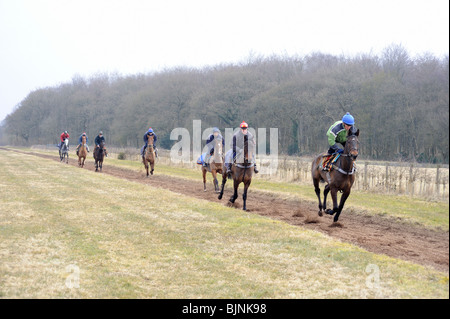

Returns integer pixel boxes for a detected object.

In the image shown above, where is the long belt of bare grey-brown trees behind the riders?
[4,45,449,163]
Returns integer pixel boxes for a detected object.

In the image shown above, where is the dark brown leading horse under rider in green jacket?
[311,130,359,222]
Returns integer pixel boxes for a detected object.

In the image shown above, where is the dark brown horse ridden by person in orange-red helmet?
[218,140,255,210]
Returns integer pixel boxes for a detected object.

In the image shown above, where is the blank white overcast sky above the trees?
[0,0,449,121]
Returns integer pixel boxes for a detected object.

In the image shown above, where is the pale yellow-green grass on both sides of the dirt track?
[0,150,449,298]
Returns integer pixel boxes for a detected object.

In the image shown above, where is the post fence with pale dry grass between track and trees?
[34,145,449,200]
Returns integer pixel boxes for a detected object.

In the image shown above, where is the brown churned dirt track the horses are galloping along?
[7,152,449,272]
